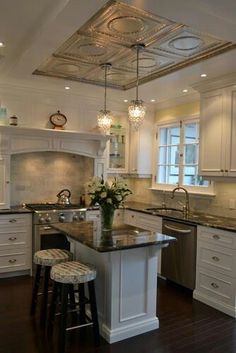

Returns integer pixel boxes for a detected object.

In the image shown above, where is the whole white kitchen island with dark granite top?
[53,221,175,343]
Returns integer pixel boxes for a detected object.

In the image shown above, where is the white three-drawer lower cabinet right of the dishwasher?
[193,226,236,317]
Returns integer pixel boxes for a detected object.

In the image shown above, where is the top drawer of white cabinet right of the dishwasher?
[198,226,236,249]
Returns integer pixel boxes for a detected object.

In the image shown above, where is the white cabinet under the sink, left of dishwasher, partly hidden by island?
[124,210,162,274]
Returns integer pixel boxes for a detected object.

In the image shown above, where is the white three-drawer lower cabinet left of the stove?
[0,214,32,276]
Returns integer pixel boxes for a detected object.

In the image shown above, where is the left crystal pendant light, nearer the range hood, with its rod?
[97,63,112,134]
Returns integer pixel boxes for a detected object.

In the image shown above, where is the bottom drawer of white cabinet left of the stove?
[0,250,31,273]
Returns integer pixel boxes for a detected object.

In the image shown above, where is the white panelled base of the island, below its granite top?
[70,239,167,343]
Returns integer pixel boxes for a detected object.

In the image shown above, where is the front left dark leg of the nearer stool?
[58,284,68,353]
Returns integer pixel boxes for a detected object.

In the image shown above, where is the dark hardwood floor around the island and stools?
[0,277,236,353]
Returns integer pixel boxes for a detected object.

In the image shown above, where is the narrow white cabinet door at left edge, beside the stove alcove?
[0,156,10,209]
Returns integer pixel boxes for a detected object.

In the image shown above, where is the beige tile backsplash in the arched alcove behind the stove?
[11,152,94,205]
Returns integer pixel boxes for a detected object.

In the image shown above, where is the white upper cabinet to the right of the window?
[195,76,236,177]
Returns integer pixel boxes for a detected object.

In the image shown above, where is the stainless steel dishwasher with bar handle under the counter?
[161,218,197,289]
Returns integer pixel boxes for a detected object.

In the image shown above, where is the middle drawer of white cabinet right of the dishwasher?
[197,242,236,277]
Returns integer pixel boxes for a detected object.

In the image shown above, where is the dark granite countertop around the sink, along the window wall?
[124,202,236,232]
